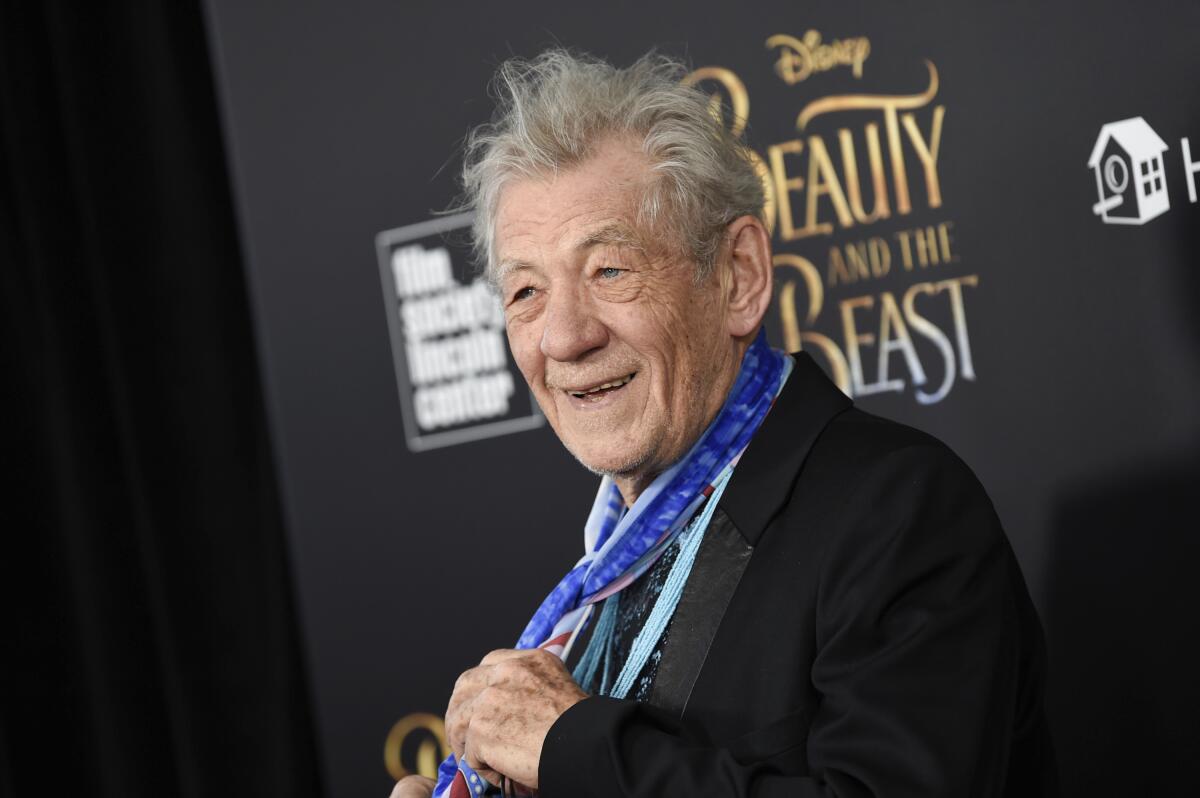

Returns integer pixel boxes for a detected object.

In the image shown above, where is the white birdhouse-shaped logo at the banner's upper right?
[1087,116,1171,224]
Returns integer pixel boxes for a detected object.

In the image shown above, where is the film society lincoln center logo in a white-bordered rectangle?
[376,214,545,451]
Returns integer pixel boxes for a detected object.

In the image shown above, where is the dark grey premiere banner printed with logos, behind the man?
[209,0,1200,798]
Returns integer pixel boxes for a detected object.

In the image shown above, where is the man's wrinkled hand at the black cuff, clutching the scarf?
[446,648,588,790]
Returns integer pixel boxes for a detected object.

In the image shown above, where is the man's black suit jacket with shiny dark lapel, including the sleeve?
[539,354,1057,798]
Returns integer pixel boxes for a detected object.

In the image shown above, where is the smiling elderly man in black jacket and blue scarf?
[392,50,1055,798]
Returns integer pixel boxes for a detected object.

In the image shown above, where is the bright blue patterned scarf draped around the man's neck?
[433,331,792,798]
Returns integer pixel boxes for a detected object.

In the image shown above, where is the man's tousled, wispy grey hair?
[462,48,764,283]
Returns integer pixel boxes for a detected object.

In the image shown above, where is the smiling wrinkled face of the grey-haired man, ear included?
[494,139,739,489]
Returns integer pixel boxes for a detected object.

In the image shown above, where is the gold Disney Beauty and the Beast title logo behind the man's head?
[686,30,979,404]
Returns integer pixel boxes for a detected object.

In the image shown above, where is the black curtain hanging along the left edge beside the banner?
[0,0,320,798]
